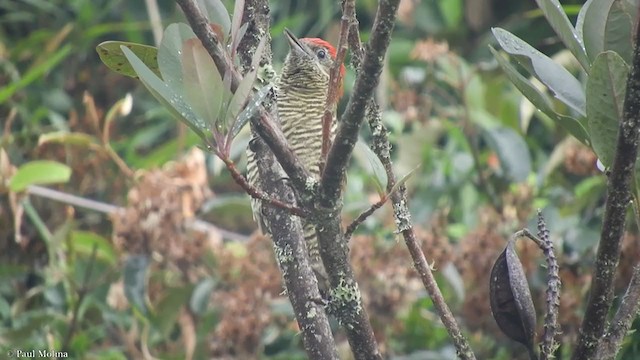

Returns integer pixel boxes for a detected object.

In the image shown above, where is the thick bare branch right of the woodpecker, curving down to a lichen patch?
[308,0,399,360]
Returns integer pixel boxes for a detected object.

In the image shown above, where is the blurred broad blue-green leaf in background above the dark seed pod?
[483,127,531,182]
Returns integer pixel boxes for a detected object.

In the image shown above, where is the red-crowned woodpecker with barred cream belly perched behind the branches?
[247,29,345,293]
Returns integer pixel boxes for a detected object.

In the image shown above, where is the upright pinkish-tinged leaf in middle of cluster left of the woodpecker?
[181,39,223,124]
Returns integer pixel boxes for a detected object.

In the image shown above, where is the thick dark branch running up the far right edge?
[572,21,640,360]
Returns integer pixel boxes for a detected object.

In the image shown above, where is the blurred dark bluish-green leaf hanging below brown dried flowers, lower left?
[122,255,150,314]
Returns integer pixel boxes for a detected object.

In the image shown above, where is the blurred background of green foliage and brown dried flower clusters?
[0,0,640,360]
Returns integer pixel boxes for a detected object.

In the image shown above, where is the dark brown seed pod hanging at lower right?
[489,237,537,359]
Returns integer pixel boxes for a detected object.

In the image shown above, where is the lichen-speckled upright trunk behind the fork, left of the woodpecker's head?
[238,0,338,360]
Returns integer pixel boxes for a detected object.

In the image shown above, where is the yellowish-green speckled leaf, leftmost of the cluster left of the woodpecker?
[96,41,160,77]
